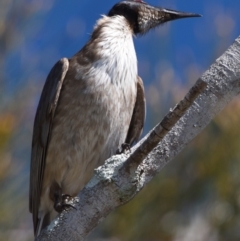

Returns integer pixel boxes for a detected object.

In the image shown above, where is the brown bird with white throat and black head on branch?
[29,0,200,237]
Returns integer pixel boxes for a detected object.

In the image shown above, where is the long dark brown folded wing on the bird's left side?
[29,58,69,232]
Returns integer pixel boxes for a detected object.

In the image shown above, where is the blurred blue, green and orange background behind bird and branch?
[0,0,240,241]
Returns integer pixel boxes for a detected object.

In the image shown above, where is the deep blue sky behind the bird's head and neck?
[6,0,240,94]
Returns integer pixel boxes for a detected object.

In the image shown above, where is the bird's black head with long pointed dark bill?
[108,0,201,34]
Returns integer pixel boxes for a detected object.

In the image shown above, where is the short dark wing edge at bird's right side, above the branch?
[125,76,146,145]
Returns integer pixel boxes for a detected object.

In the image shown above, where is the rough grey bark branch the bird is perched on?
[36,37,240,241]
